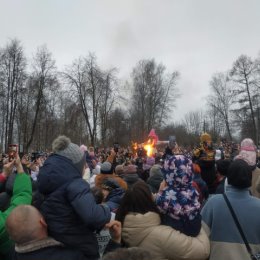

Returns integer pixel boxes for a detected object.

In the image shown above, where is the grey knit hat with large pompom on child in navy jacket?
[52,135,86,174]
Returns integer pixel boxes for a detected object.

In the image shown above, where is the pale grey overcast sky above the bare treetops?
[0,0,260,120]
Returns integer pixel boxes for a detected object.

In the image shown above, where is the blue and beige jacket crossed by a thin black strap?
[201,185,260,260]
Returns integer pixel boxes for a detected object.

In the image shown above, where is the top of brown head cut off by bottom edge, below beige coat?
[102,247,150,260]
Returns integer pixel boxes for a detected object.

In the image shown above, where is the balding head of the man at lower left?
[6,205,48,245]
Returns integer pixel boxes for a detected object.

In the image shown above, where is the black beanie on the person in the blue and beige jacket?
[227,159,252,189]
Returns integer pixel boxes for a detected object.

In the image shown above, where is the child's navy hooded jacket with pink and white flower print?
[156,155,200,220]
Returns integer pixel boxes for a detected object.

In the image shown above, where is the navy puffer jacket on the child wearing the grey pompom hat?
[38,154,111,259]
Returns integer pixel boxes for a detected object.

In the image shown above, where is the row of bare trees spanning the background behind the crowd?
[0,39,260,151]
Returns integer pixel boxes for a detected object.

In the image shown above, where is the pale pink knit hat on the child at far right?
[235,138,256,166]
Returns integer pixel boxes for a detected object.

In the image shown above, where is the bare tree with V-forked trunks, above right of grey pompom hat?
[63,54,112,146]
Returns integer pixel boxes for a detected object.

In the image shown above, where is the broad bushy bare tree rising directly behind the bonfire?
[131,60,178,141]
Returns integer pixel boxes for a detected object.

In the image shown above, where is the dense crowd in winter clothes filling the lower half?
[0,133,260,260]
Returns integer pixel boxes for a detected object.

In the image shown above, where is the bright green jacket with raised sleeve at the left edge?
[0,173,32,255]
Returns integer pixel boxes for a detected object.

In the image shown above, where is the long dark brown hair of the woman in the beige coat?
[116,181,159,223]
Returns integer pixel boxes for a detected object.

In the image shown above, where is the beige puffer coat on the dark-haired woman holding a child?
[122,212,210,260]
